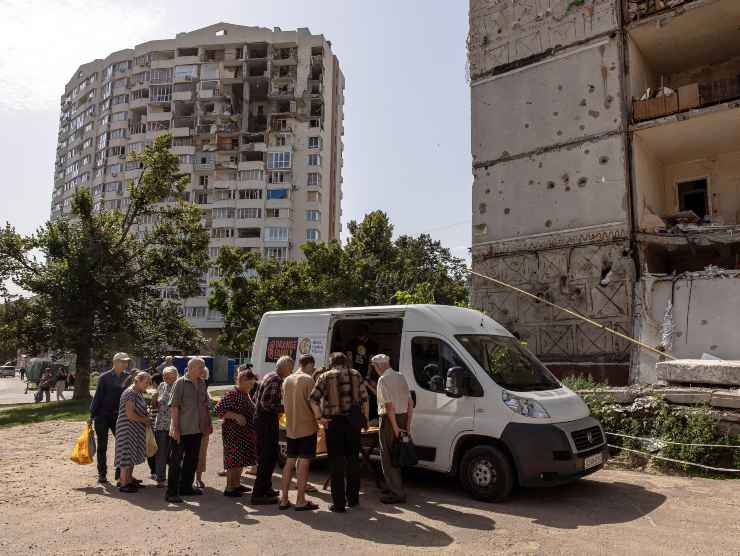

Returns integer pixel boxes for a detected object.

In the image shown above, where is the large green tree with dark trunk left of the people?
[0,135,208,399]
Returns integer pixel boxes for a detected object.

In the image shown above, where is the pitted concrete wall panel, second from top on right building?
[471,38,622,165]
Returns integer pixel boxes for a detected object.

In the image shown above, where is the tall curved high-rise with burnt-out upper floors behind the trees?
[51,23,344,336]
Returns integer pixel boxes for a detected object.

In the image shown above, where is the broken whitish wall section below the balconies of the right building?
[634,271,740,382]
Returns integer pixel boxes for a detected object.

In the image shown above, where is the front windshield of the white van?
[455,334,561,392]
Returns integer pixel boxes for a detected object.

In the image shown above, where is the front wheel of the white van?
[460,446,514,502]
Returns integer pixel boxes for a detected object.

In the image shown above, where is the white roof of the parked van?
[264,304,511,336]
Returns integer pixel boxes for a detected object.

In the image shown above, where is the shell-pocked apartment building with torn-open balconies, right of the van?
[469,0,740,384]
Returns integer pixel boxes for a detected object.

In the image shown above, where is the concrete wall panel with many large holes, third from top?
[473,135,628,244]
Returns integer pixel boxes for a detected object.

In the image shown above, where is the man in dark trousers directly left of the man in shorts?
[252,355,293,505]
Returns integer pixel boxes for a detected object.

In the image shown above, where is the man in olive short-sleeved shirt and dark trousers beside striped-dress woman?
[165,357,210,504]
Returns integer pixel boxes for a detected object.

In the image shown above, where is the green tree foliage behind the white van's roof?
[209,211,467,354]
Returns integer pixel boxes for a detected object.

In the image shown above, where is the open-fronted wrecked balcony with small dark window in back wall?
[632,109,740,273]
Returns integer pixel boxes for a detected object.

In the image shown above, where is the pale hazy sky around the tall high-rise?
[0,0,472,256]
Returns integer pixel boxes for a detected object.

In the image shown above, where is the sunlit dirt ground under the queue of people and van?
[0,422,740,556]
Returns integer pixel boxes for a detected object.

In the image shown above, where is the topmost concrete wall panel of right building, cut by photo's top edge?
[468,0,619,80]
